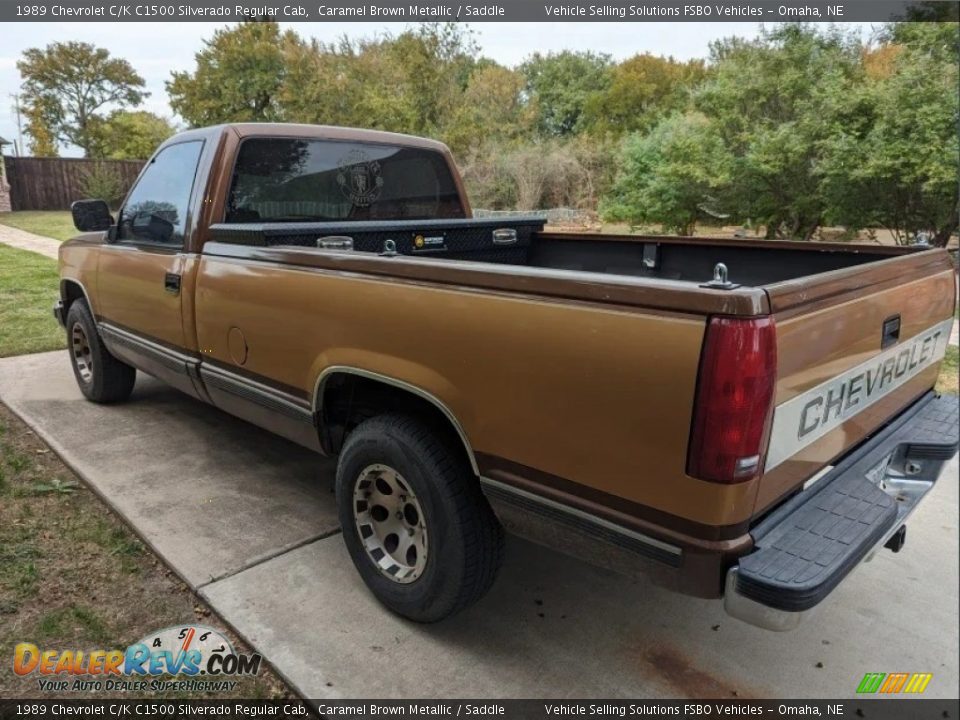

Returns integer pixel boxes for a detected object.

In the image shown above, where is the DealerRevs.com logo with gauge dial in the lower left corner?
[13,625,261,692]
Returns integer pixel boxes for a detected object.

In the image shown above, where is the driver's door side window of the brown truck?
[117,140,203,247]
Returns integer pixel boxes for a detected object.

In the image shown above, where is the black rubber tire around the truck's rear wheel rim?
[337,414,503,623]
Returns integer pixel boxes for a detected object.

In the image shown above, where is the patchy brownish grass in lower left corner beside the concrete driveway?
[0,404,294,704]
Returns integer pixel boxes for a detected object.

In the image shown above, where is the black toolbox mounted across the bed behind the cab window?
[210,216,546,264]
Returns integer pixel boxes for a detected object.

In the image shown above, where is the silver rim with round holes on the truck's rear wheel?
[353,465,428,584]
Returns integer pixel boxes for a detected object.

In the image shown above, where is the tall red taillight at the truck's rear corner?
[687,317,777,483]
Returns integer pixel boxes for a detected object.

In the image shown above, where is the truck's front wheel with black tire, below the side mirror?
[66,300,137,403]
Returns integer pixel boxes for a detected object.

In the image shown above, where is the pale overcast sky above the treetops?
[0,22,869,155]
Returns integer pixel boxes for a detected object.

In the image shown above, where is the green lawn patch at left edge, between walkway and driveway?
[0,244,66,357]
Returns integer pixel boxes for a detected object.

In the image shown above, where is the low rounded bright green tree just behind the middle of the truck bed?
[600,113,733,235]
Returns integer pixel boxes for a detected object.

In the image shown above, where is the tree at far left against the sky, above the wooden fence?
[17,42,149,155]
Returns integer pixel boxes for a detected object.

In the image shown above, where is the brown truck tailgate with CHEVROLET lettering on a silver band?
[755,250,956,514]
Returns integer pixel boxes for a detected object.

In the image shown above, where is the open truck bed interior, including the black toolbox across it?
[210,217,915,287]
